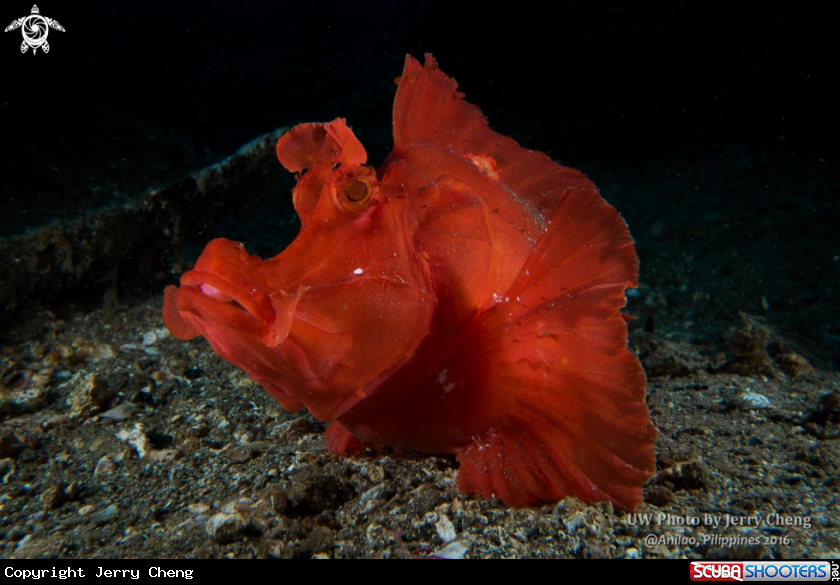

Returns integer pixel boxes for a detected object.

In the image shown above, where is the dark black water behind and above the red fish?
[0,0,840,369]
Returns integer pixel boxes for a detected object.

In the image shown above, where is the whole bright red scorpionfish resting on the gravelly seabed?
[163,55,656,509]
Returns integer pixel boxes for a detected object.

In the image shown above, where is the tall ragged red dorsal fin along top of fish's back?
[394,54,594,223]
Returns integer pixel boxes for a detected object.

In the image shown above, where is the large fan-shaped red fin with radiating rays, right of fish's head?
[450,188,656,509]
